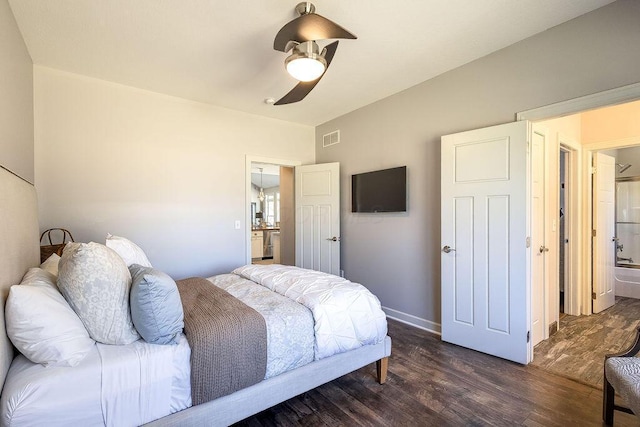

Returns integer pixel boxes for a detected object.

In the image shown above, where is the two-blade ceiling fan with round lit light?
[273,2,357,105]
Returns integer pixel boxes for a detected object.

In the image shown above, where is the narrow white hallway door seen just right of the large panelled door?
[531,124,549,346]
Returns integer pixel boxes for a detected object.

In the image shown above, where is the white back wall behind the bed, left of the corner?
[34,66,315,278]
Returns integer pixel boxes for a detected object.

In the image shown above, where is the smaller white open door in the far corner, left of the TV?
[295,163,340,276]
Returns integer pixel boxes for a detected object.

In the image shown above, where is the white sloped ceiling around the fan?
[9,0,613,125]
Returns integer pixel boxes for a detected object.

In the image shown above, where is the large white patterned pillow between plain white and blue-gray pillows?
[58,242,140,344]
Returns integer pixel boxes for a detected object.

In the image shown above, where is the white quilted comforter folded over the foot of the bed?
[233,264,387,360]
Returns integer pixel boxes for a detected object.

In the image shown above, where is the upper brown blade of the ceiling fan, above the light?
[273,13,357,52]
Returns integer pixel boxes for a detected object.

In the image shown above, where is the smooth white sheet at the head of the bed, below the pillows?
[0,336,191,427]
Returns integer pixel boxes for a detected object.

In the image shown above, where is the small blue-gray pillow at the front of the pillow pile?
[129,264,184,344]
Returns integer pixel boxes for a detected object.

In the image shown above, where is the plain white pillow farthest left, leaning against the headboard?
[5,268,95,366]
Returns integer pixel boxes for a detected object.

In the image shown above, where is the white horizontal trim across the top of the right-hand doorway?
[516,83,640,121]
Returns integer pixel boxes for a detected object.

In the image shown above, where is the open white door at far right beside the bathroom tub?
[593,153,616,313]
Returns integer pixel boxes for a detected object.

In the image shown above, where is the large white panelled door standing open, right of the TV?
[441,121,532,364]
